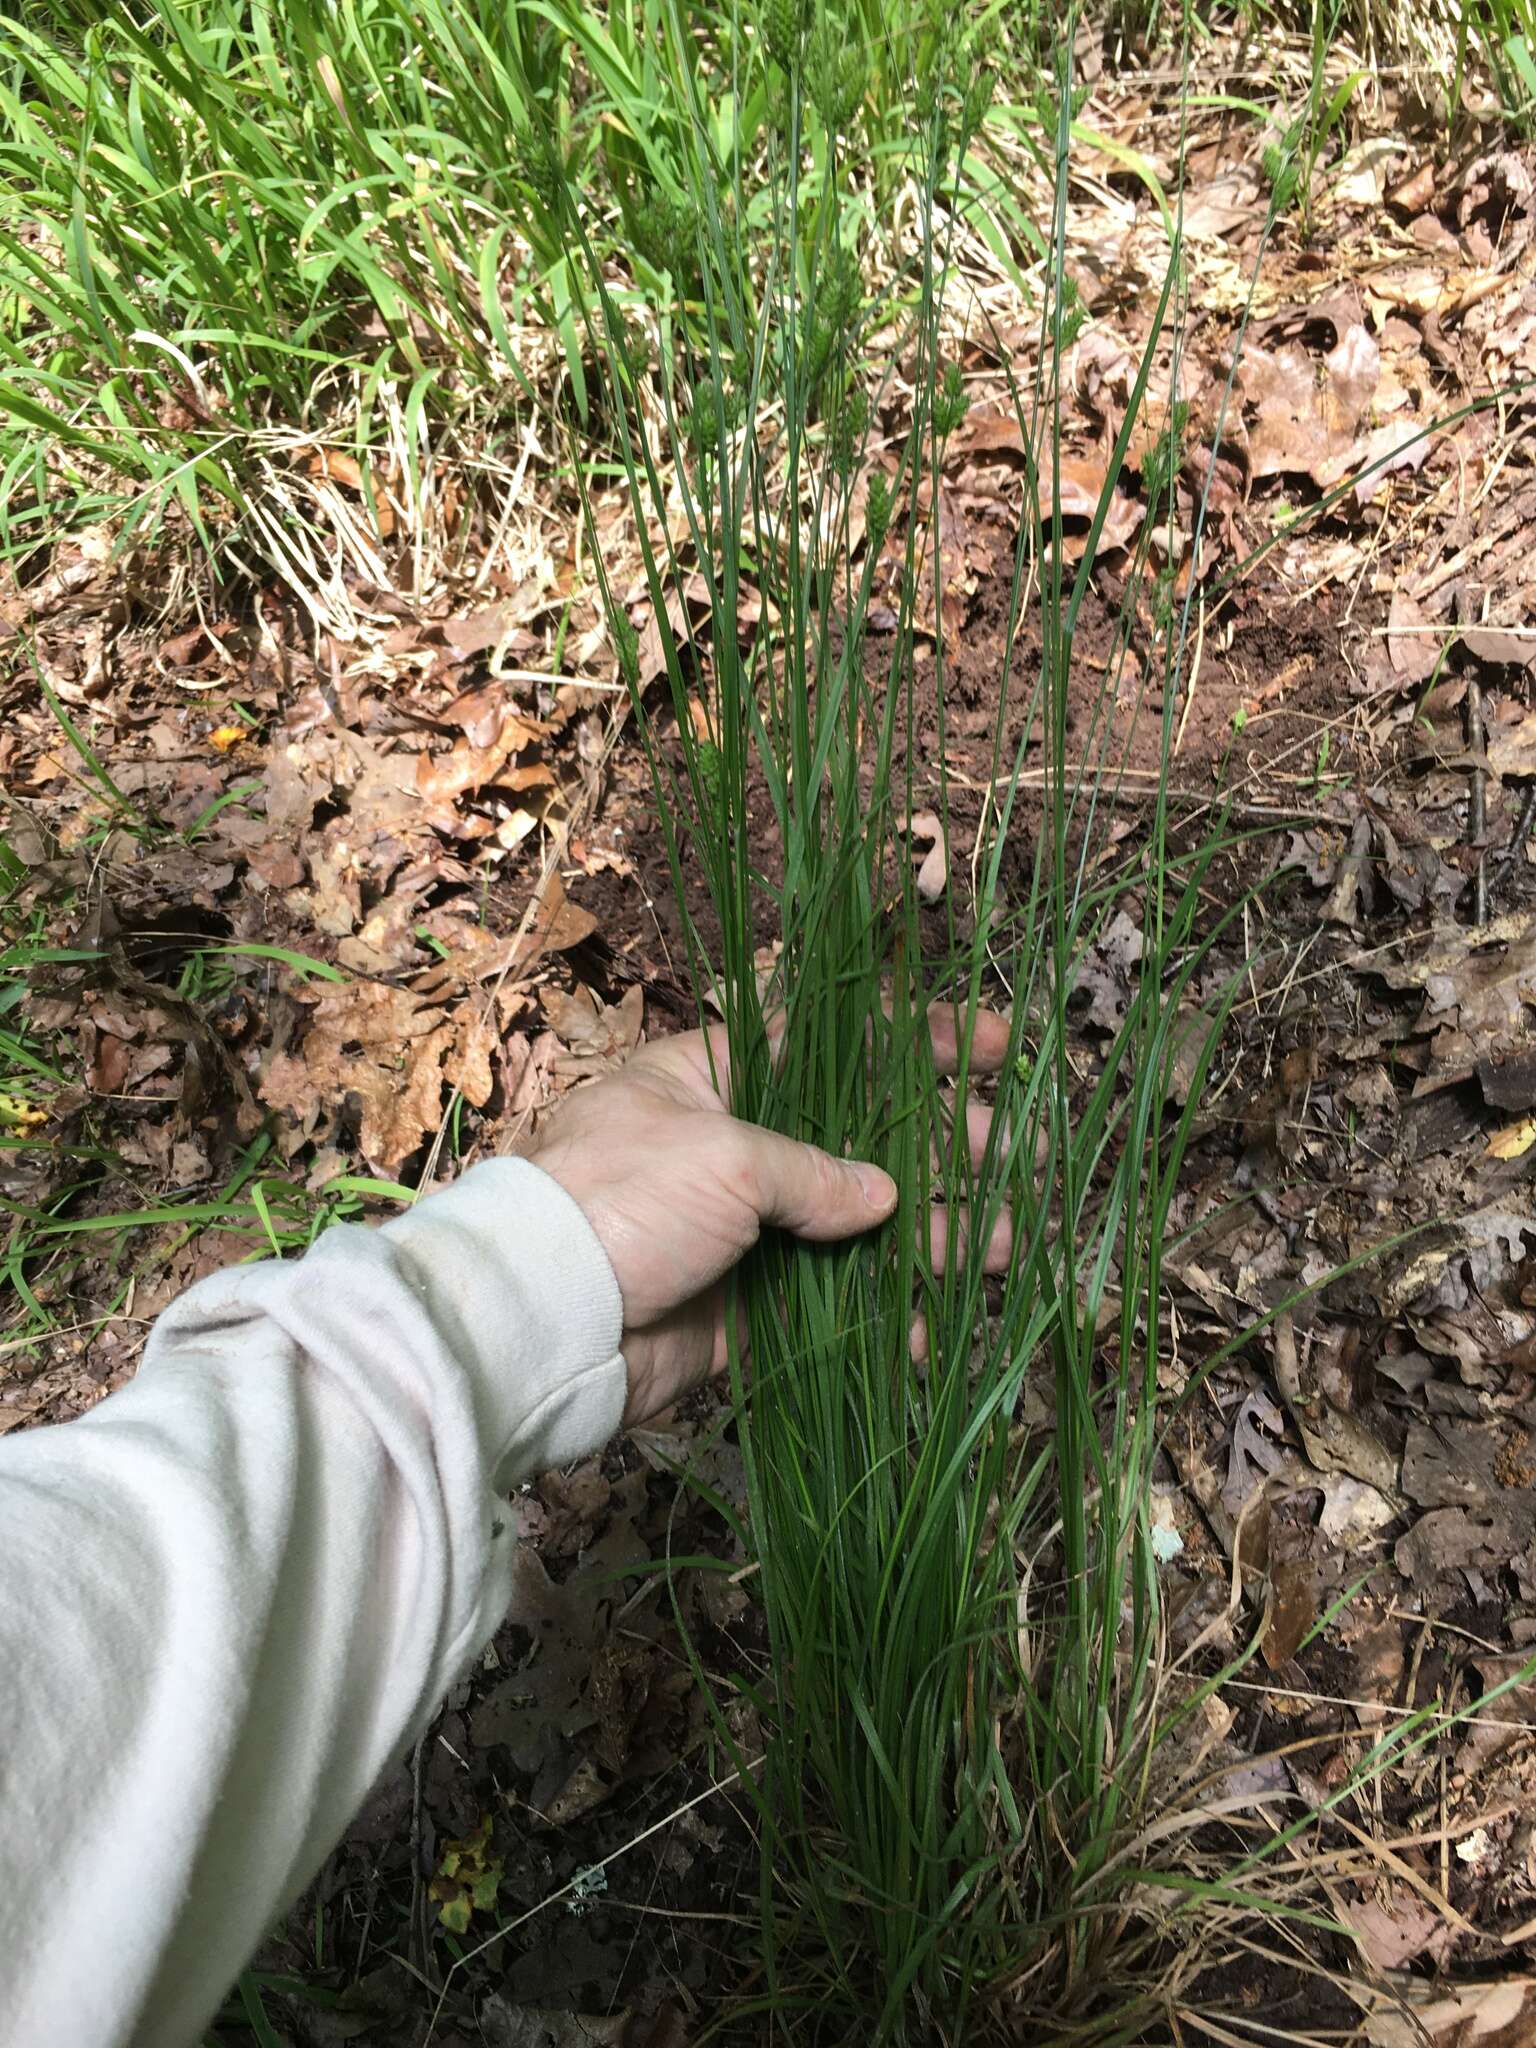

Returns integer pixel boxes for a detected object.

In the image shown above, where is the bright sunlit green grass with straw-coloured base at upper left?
[0,0,1032,596]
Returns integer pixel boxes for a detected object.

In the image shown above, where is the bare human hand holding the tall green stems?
[524,1006,1008,1423]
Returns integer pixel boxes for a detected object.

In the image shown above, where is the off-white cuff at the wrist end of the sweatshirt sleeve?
[370,1159,627,1491]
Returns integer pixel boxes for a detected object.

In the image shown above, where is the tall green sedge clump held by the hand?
[565,8,1269,2042]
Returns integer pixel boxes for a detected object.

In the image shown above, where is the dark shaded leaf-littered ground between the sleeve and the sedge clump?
[260,1395,764,2048]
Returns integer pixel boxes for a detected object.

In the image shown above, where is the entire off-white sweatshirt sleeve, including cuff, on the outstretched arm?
[0,1159,625,2048]
